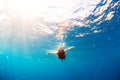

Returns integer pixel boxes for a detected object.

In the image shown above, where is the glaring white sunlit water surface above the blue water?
[0,0,119,40]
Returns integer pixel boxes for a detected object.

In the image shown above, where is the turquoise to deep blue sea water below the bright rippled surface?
[0,1,120,80]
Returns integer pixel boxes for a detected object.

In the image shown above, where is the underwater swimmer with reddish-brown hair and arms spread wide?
[47,46,74,59]
